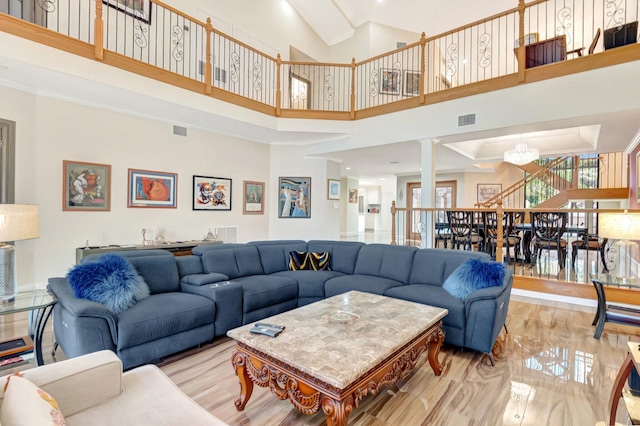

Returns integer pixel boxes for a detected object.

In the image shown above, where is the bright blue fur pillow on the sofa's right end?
[442,259,504,299]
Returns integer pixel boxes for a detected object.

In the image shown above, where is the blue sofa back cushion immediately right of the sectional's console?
[200,244,264,280]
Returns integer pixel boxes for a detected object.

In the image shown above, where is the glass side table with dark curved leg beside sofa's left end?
[0,289,56,365]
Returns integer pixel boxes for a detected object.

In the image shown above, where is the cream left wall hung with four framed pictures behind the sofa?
[0,86,274,287]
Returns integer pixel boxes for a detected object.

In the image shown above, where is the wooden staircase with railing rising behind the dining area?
[475,153,629,209]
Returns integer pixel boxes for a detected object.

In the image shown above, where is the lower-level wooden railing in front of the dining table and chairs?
[391,202,640,284]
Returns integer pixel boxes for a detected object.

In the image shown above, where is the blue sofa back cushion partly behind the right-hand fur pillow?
[410,249,491,287]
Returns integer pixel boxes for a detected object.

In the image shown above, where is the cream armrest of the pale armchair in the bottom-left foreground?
[0,351,123,416]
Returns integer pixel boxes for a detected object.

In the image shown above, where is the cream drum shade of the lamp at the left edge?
[0,204,40,243]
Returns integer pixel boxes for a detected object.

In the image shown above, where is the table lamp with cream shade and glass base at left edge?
[0,204,40,303]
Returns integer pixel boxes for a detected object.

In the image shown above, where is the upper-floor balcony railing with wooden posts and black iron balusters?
[0,0,640,120]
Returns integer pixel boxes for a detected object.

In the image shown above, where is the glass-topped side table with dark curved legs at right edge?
[589,274,640,339]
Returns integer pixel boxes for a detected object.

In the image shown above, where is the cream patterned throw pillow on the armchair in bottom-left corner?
[2,373,65,426]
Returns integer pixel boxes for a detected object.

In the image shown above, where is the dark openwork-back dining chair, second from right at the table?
[531,212,568,269]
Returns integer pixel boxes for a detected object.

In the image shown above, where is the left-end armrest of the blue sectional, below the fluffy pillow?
[47,278,118,346]
